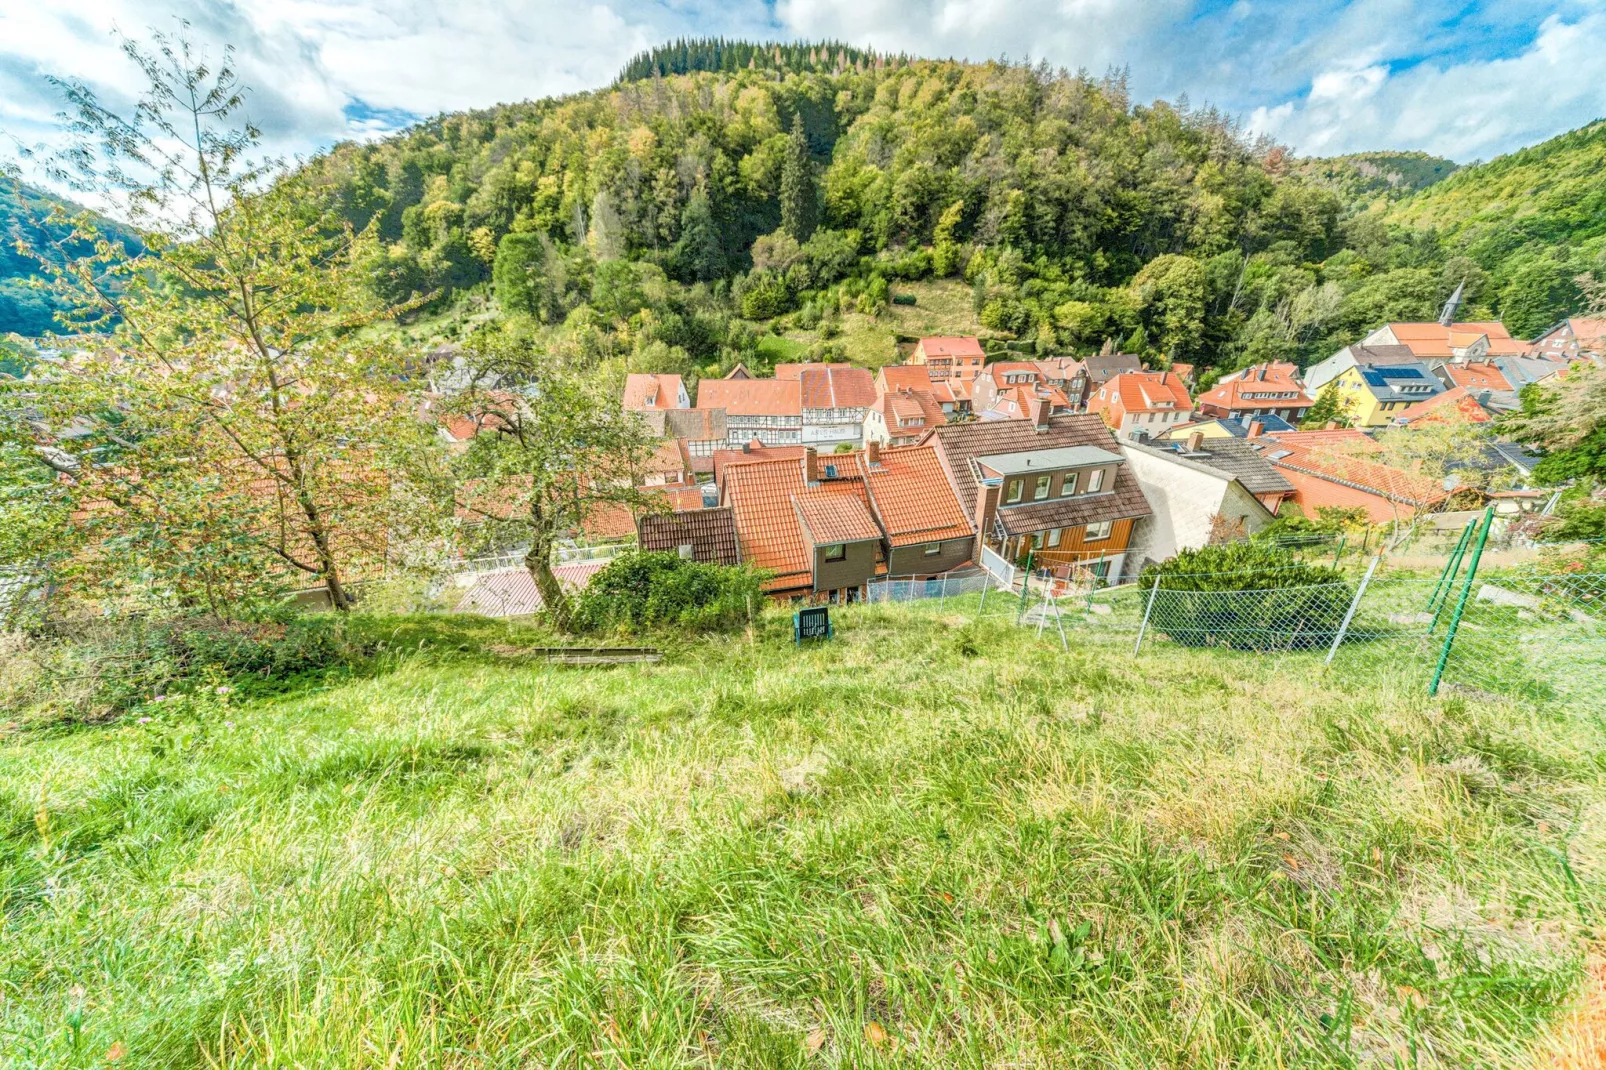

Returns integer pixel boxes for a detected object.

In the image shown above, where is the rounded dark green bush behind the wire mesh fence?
[1139,543,1354,651]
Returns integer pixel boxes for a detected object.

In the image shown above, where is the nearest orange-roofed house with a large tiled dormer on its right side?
[719,448,885,602]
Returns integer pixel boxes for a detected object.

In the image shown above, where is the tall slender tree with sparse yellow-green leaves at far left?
[12,35,443,609]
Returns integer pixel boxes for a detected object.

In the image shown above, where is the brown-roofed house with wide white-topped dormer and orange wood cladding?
[931,400,1150,582]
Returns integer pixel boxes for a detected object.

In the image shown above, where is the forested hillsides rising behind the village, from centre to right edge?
[292,52,1606,380]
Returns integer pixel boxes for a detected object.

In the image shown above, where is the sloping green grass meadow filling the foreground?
[0,604,1606,1068]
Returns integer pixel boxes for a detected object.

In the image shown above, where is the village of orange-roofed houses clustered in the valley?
[442,292,1606,612]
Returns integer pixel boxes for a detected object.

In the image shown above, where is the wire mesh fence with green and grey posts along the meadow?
[944,543,1606,709]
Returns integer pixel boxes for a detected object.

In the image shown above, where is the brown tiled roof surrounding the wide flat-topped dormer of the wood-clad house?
[931,413,1153,530]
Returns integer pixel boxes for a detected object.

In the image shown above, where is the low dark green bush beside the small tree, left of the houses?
[573,553,764,631]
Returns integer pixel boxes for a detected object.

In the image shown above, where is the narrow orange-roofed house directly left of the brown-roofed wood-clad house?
[854,442,976,578]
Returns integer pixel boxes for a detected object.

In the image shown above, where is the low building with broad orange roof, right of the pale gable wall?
[1256,427,1450,524]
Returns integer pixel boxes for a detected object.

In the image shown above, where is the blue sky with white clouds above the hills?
[0,0,1606,181]
